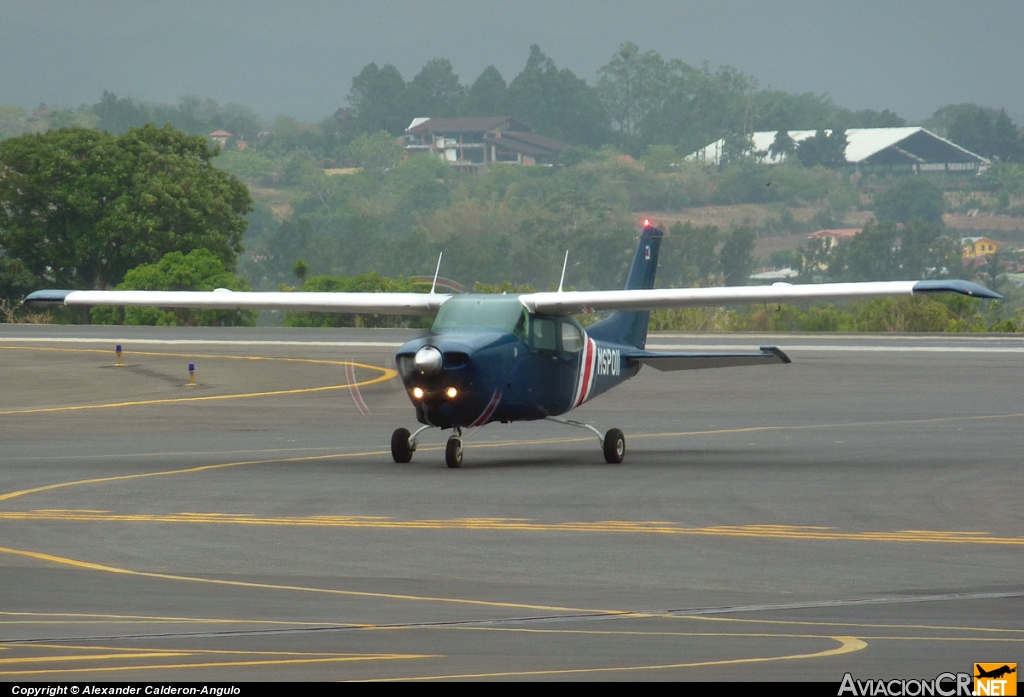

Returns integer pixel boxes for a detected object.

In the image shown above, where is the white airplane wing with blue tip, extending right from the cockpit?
[519,280,1002,314]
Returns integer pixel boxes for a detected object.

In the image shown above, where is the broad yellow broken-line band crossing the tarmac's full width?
[0,507,1024,547]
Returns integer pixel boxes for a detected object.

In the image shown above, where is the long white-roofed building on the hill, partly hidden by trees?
[686,126,990,173]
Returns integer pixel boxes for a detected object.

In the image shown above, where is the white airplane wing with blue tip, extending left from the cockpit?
[25,289,452,314]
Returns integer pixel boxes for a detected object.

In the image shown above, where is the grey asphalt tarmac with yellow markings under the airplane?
[0,325,1024,683]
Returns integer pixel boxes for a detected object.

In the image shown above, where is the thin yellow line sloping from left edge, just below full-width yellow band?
[0,547,622,617]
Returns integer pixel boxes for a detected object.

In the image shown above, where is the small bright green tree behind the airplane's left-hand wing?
[90,249,256,326]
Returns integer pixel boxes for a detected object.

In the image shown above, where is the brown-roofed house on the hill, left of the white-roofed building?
[403,117,568,170]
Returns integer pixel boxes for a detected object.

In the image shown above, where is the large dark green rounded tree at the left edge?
[0,126,252,288]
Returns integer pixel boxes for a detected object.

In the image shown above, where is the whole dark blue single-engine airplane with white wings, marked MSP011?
[25,221,1001,468]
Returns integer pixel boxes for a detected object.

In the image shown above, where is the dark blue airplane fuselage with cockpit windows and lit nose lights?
[395,296,639,429]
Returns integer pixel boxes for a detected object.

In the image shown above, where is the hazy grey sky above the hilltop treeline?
[0,0,1024,124]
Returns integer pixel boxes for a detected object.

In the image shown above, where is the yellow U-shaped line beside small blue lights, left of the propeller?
[0,346,398,417]
